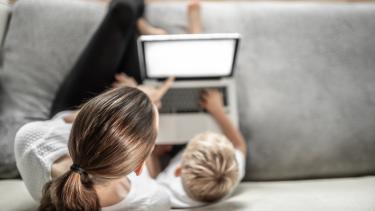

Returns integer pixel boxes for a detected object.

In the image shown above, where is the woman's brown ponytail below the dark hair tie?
[39,167,100,211]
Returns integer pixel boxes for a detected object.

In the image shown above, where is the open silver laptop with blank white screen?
[138,33,240,144]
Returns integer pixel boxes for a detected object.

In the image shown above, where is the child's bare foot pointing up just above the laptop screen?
[187,0,202,34]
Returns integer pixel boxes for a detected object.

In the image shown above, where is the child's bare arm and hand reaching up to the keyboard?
[200,90,247,156]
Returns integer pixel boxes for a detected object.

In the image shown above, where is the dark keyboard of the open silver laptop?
[160,87,227,113]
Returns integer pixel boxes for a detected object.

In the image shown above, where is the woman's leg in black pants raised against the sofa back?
[51,0,142,116]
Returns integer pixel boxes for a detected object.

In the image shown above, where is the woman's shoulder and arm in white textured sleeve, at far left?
[14,119,70,201]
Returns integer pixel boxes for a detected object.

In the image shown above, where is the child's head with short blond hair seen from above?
[179,132,239,202]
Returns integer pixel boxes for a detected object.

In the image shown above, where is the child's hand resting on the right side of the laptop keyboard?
[199,89,224,115]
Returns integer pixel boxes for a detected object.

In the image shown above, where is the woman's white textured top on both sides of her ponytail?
[15,112,170,211]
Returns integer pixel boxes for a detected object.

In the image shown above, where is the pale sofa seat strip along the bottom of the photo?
[0,176,375,211]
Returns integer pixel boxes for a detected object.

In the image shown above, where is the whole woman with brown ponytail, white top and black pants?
[15,0,171,210]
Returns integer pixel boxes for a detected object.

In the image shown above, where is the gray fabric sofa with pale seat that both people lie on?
[0,0,375,211]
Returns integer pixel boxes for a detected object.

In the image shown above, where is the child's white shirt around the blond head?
[156,150,246,208]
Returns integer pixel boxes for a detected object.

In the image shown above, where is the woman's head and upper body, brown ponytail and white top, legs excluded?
[15,87,170,210]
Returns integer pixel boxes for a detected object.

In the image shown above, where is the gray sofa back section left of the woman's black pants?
[0,0,105,178]
